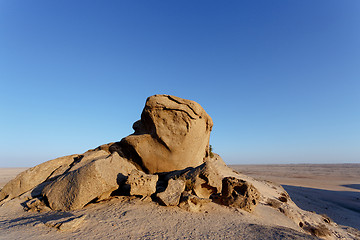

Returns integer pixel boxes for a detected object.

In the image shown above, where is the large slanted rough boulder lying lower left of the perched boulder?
[42,153,136,210]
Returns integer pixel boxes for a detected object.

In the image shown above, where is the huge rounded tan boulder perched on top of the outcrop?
[118,95,213,173]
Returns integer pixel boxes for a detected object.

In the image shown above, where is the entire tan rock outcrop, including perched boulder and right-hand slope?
[0,95,354,237]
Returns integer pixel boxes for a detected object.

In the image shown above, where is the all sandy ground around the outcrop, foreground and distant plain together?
[0,164,360,239]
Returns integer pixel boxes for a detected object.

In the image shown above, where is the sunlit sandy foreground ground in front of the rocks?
[0,199,315,240]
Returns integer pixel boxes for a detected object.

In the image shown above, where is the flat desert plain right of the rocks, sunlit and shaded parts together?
[231,164,360,229]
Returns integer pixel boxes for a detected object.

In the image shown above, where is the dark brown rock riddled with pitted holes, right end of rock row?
[221,177,260,212]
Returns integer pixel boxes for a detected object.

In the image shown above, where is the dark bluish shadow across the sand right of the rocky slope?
[283,184,360,230]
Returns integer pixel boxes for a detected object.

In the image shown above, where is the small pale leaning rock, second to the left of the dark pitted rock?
[156,179,185,206]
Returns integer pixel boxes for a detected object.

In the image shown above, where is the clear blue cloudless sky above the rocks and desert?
[0,0,360,167]
